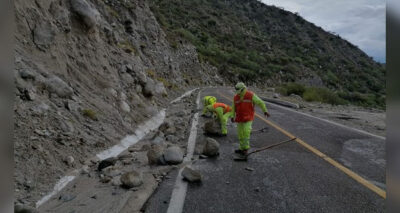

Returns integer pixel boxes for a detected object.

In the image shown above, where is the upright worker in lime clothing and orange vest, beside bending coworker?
[232,82,270,155]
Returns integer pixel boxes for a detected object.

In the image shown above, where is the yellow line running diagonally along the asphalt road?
[217,92,386,199]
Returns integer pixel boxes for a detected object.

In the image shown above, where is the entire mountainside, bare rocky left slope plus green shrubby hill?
[14,0,385,208]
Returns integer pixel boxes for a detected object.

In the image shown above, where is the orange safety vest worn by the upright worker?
[233,91,254,122]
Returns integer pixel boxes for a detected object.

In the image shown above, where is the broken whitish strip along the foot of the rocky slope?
[36,109,166,208]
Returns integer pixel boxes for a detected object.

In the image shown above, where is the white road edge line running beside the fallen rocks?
[167,88,201,213]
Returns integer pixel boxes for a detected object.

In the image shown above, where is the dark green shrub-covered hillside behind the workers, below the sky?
[150,0,385,107]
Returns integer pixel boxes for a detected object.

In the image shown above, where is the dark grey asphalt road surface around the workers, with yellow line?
[146,88,386,213]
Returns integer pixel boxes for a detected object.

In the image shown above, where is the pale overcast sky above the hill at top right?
[261,0,386,62]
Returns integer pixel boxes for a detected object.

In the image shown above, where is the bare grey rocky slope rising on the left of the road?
[14,0,222,204]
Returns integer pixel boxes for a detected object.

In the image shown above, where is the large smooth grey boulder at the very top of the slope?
[71,0,99,29]
